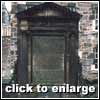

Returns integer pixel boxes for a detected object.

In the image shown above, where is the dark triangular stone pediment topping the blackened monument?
[16,2,81,19]
